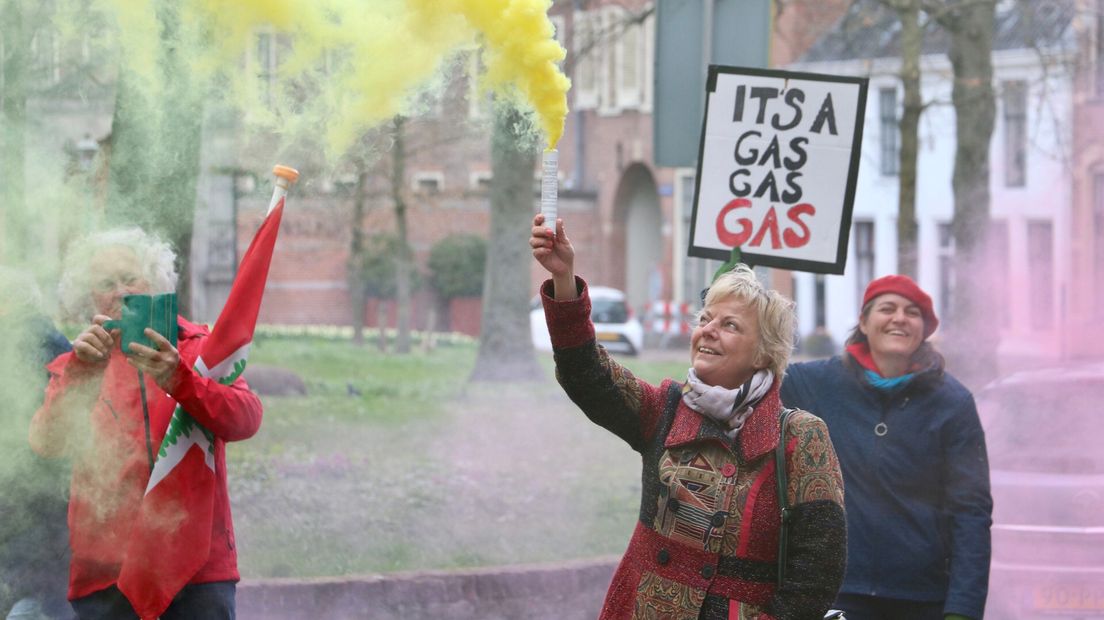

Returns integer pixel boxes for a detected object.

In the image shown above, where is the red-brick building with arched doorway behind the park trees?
[193,0,846,332]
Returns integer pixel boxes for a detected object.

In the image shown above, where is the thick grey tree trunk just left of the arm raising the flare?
[471,104,543,382]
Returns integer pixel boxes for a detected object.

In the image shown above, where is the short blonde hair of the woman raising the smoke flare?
[698,263,797,378]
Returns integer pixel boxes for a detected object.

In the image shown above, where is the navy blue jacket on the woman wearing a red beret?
[782,356,992,618]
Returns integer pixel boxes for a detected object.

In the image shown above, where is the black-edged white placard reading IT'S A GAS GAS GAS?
[689,65,867,274]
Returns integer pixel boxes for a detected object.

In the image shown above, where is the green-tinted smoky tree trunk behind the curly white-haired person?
[107,0,203,316]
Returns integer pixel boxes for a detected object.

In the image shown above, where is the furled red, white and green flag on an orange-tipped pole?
[118,167,294,620]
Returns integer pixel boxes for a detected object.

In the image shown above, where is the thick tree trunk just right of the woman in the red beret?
[944,0,999,387]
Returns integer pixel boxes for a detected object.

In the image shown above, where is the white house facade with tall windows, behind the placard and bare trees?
[787,2,1074,359]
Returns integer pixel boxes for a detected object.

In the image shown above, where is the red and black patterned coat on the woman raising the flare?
[541,278,846,620]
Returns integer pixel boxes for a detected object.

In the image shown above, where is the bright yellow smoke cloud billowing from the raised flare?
[103,0,571,157]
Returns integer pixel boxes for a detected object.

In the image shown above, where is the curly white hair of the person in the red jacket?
[57,228,177,321]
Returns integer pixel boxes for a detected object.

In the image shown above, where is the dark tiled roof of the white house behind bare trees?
[799,0,1076,63]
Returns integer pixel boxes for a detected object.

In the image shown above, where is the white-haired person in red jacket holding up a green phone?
[30,228,262,620]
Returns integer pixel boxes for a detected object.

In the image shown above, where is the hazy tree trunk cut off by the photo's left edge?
[0,0,31,265]
